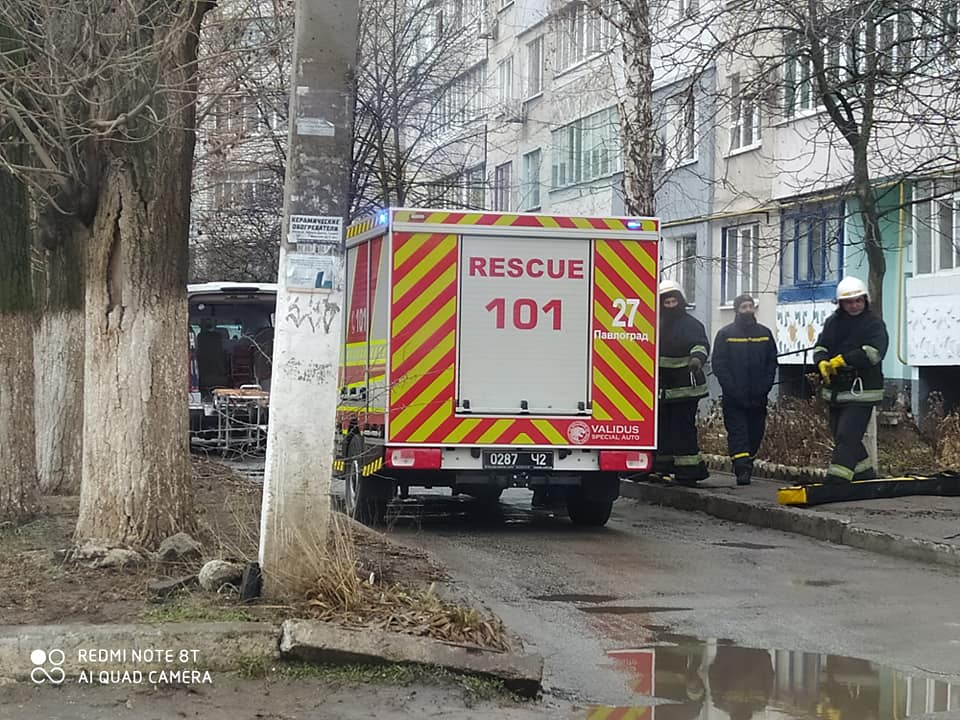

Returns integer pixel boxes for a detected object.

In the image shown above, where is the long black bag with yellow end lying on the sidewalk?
[777,470,960,507]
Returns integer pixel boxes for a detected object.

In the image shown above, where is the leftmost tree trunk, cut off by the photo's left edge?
[0,164,39,523]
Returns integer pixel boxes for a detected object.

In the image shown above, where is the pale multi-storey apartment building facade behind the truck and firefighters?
[193,0,960,410]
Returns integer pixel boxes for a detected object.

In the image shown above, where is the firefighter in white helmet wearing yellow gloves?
[813,277,889,483]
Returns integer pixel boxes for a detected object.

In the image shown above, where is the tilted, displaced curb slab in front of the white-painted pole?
[280,620,543,697]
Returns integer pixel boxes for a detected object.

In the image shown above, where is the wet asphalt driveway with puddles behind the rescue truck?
[390,490,960,720]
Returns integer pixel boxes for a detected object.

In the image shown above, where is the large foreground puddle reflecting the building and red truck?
[586,633,960,720]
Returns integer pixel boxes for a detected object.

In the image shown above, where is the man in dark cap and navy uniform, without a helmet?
[711,295,777,485]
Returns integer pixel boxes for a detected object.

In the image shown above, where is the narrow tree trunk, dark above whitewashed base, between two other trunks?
[33,218,86,495]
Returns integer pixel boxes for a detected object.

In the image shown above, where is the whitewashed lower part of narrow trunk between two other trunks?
[33,309,84,495]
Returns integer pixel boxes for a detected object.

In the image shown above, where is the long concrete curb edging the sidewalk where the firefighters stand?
[620,480,960,568]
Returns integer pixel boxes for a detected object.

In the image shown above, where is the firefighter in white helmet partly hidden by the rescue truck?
[654,280,710,485]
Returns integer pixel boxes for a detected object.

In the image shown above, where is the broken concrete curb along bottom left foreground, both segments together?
[0,620,543,697]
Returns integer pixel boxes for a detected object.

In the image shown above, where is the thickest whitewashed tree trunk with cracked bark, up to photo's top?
[76,3,206,547]
